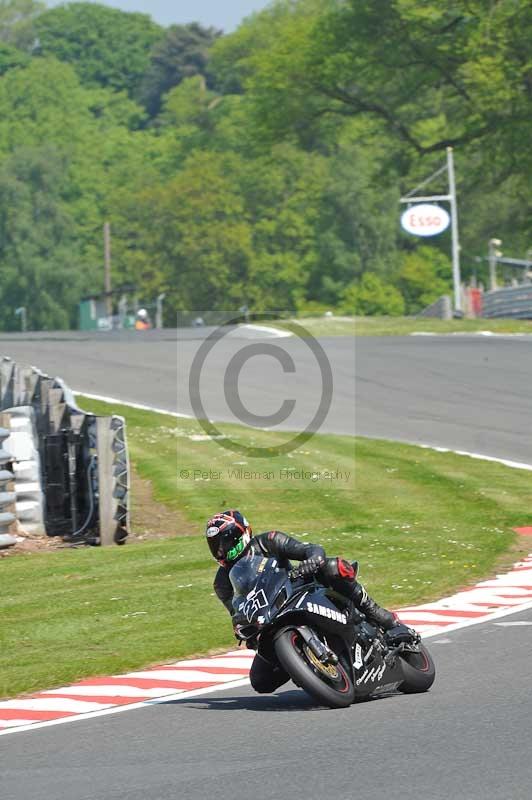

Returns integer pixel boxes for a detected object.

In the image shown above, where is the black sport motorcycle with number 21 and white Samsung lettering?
[235,556,435,708]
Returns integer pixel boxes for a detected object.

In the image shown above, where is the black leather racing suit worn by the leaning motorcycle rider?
[214,531,395,693]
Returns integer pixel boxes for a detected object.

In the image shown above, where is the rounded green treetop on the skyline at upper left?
[35,3,163,97]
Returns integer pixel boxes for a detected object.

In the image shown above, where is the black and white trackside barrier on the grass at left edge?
[0,358,129,545]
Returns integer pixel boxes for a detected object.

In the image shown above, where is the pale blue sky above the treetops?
[47,0,269,32]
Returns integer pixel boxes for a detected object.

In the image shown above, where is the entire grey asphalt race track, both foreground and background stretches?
[0,331,532,800]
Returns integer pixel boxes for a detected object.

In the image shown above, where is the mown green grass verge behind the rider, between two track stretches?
[0,399,532,696]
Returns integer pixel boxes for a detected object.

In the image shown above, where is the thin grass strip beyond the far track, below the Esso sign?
[264,317,532,336]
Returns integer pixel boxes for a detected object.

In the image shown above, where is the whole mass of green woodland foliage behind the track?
[0,0,532,327]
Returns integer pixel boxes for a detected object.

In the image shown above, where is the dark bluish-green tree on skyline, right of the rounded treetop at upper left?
[140,22,221,117]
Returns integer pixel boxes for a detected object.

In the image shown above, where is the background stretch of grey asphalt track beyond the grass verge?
[0,329,532,462]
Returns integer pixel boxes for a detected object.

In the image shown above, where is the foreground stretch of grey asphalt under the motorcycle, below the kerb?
[1,609,532,800]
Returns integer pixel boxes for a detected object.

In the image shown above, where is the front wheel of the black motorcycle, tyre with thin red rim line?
[275,628,355,708]
